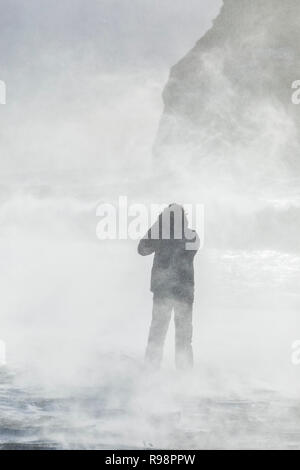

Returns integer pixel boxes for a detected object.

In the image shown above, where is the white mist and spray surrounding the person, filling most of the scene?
[0,0,300,448]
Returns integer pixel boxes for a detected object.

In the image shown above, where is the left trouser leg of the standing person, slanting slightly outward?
[146,295,172,367]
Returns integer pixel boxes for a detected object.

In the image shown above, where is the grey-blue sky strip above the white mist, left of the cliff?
[0,0,221,67]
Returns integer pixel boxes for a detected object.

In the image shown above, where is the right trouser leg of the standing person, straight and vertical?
[174,300,194,369]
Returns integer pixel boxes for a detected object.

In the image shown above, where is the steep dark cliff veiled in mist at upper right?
[154,0,300,180]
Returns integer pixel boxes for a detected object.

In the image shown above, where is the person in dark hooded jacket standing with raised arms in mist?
[138,204,200,369]
